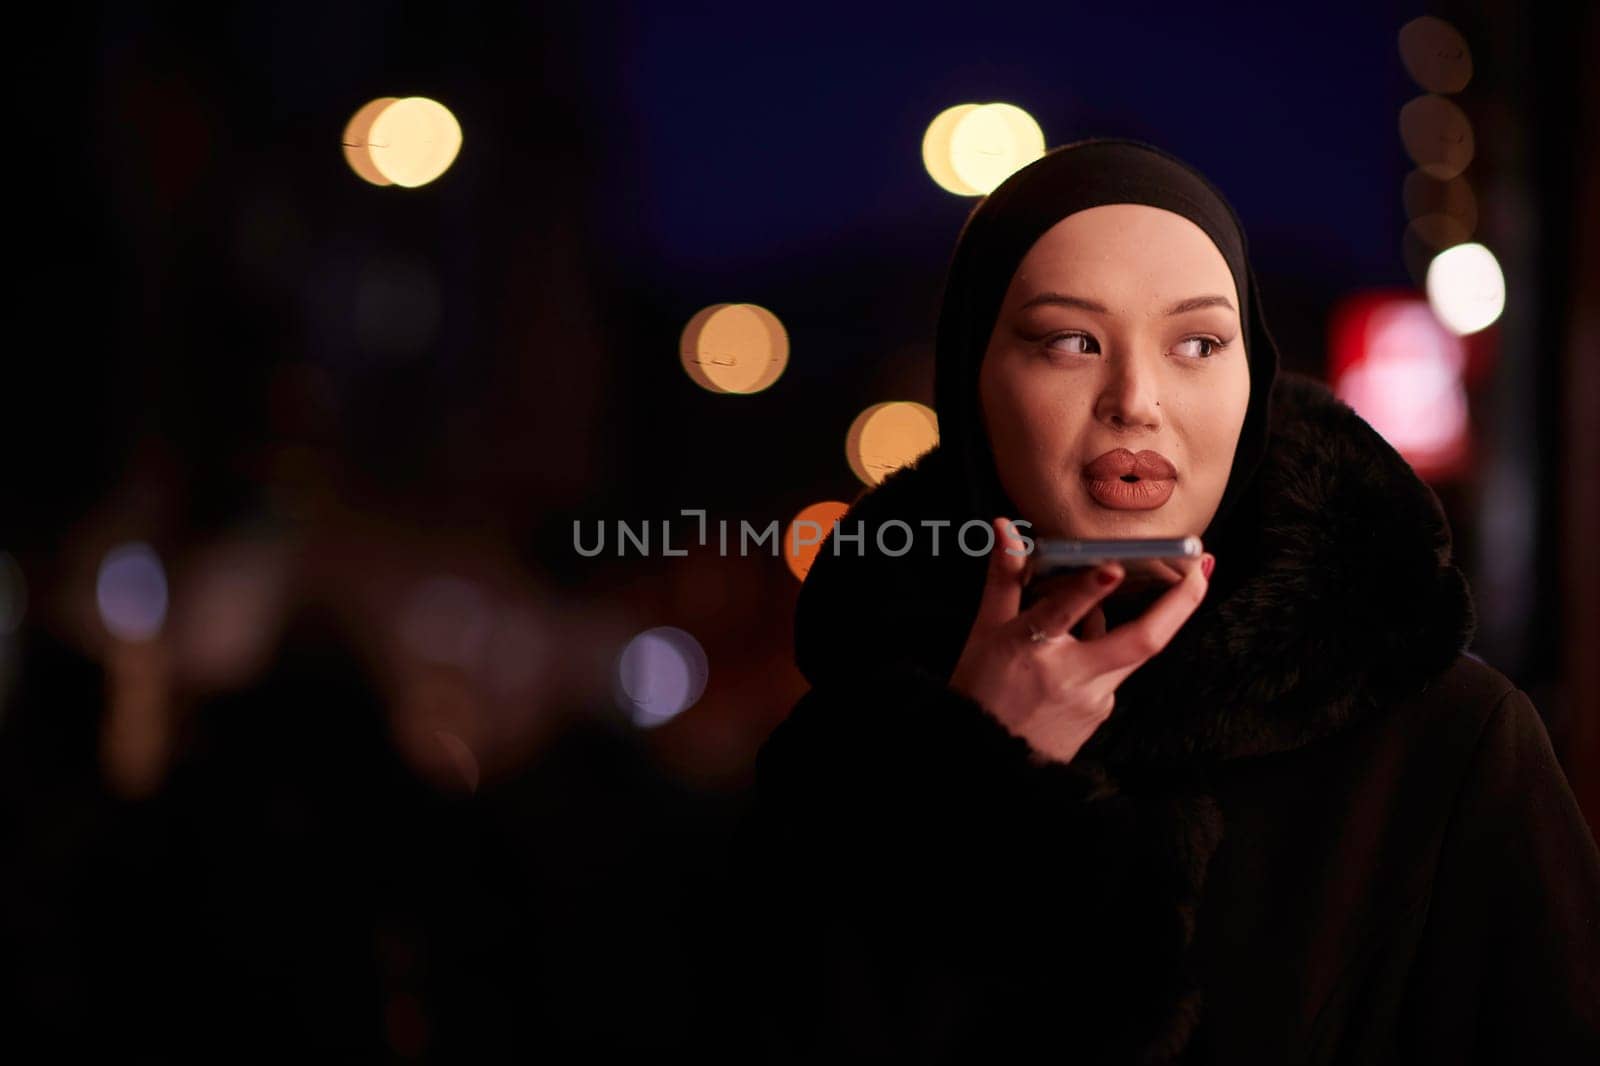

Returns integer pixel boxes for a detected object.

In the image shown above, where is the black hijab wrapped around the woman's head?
[934,138,1278,544]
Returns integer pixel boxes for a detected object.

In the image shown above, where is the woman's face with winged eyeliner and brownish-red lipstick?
[979,203,1250,538]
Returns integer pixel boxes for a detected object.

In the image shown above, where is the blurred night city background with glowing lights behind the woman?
[0,0,1600,1061]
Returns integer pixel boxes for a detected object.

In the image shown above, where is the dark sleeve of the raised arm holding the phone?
[741,663,1200,1061]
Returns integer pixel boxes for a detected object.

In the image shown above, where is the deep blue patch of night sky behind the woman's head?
[592,3,1421,285]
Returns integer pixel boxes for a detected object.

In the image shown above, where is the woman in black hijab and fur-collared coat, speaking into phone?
[744,139,1600,1063]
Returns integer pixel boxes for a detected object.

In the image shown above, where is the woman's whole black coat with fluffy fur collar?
[739,375,1600,1063]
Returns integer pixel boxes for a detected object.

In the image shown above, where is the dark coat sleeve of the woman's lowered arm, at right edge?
[1402,690,1600,1064]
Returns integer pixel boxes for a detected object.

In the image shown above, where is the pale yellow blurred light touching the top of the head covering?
[922,102,1045,197]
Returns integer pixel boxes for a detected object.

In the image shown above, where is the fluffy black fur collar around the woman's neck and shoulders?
[795,373,1475,765]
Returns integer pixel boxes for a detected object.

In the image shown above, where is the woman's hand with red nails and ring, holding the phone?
[950,517,1211,762]
